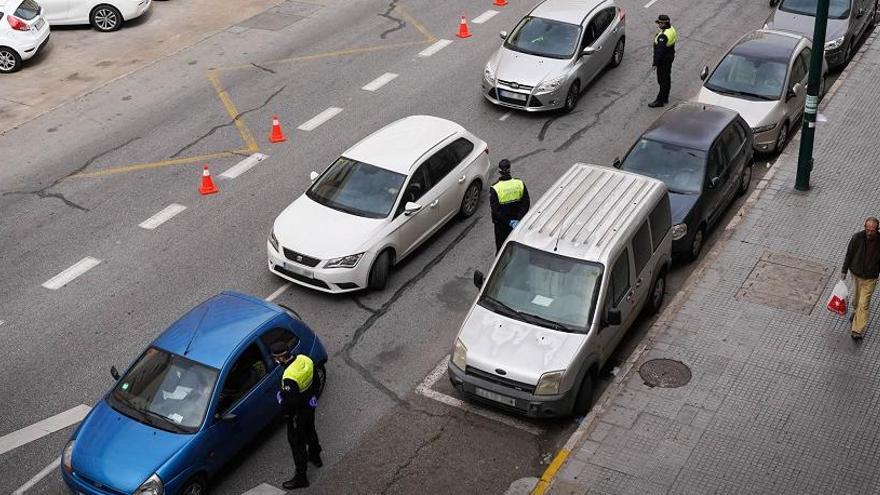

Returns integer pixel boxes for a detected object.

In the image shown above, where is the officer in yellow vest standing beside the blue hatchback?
[269,342,324,490]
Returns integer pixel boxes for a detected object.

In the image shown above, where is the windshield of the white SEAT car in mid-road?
[306,156,406,218]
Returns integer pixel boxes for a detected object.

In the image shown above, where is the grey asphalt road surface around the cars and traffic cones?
[0,0,836,494]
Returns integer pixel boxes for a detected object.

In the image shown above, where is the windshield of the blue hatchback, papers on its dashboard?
[109,347,217,433]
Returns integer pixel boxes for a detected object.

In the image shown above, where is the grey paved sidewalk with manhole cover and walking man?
[549,32,880,494]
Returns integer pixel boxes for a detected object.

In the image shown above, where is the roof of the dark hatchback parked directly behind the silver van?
[642,102,739,151]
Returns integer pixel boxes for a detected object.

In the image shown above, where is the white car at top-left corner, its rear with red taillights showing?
[0,0,49,73]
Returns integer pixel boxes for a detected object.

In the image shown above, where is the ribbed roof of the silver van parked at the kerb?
[510,163,667,265]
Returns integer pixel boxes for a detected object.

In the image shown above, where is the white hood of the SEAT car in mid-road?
[273,194,386,260]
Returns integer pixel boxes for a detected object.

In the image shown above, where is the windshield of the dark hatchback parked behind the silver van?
[621,138,706,194]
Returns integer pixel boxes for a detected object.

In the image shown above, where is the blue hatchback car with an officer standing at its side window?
[61,292,327,495]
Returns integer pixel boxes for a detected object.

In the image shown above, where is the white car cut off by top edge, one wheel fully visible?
[40,0,152,31]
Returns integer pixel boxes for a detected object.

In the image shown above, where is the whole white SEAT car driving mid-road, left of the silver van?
[266,115,489,293]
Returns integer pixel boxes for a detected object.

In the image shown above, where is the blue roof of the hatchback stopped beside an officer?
[153,291,283,369]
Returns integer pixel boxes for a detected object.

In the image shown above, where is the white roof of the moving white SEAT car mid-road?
[342,115,465,174]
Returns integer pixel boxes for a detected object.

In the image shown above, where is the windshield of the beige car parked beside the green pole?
[706,53,787,100]
